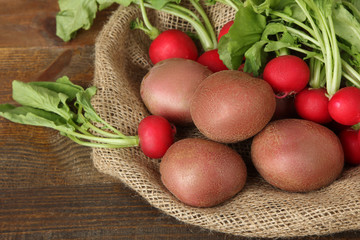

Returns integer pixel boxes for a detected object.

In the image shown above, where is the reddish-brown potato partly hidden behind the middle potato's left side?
[140,58,212,125]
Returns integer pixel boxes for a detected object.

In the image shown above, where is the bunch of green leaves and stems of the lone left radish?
[0,77,139,148]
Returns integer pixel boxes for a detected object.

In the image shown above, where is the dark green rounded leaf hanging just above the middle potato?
[218,3,266,69]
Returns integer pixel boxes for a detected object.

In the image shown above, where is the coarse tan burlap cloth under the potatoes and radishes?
[92,3,360,238]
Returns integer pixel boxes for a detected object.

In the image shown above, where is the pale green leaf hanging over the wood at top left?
[56,0,97,42]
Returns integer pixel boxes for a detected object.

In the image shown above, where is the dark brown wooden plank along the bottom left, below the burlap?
[0,184,223,239]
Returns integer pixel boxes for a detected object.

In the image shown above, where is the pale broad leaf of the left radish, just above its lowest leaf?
[12,80,73,120]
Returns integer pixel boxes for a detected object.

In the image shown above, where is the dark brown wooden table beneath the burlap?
[0,0,360,239]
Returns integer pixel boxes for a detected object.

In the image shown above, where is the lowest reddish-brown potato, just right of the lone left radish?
[160,138,247,207]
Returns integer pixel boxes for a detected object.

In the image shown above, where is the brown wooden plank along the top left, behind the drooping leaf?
[0,0,118,48]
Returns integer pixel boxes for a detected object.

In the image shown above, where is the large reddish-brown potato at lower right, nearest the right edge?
[251,119,344,192]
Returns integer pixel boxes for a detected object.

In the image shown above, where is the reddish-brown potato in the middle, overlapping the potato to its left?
[190,70,276,143]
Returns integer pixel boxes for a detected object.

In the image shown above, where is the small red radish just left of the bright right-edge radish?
[295,88,332,124]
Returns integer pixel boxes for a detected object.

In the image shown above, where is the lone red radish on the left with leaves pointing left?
[138,115,176,158]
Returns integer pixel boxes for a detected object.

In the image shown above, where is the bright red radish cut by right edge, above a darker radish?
[328,87,360,126]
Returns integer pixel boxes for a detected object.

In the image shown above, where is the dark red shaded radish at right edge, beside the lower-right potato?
[339,127,360,165]
